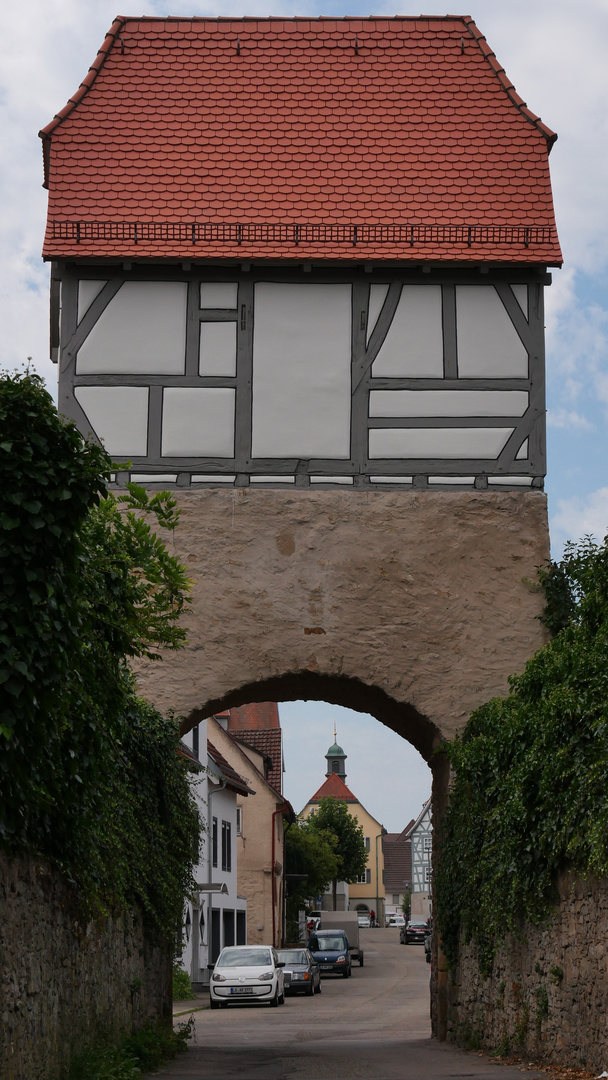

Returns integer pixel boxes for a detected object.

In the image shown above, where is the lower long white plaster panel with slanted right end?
[369,428,513,458]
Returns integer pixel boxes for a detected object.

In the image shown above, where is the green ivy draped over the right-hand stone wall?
[435,538,608,972]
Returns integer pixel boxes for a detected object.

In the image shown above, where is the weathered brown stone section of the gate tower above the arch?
[138,488,549,758]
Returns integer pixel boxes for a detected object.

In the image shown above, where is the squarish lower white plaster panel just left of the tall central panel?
[162,387,234,458]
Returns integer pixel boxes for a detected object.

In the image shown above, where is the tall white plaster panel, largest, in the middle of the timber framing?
[253,282,351,458]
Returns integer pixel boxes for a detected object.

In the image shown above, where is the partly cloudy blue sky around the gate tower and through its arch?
[0,0,608,831]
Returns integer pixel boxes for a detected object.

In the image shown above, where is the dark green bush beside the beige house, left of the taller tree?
[285,815,338,924]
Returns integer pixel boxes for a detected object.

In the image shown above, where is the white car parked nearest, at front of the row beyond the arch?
[210,945,285,1009]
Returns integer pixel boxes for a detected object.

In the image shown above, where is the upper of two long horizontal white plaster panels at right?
[369,390,528,416]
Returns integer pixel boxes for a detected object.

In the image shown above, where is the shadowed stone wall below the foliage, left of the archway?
[0,852,172,1080]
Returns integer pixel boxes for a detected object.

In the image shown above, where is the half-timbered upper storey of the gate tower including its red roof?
[41,16,562,488]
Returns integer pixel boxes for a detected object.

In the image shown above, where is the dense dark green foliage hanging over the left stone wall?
[0,374,198,936]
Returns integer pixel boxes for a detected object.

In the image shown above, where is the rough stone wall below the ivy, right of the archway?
[448,875,608,1075]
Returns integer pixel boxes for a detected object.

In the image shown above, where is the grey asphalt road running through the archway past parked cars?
[154,929,546,1080]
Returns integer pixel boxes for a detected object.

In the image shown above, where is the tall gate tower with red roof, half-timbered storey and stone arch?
[41,16,562,760]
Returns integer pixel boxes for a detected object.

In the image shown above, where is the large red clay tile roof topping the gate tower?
[40,15,562,265]
